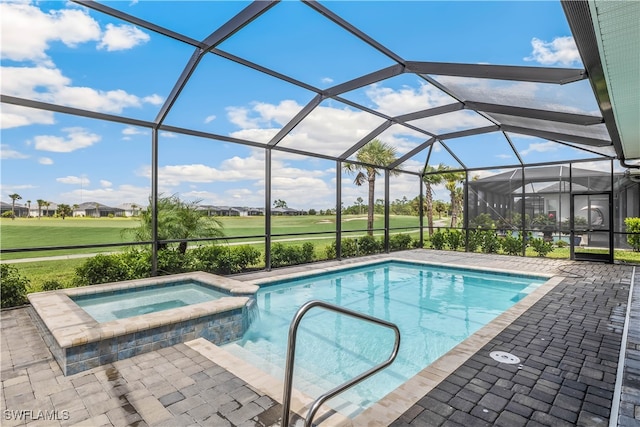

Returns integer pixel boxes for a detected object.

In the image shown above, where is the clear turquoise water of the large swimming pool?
[224,261,546,416]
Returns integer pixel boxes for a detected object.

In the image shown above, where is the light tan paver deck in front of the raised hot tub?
[0,308,281,427]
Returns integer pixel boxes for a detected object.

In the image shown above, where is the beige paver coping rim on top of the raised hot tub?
[28,272,258,348]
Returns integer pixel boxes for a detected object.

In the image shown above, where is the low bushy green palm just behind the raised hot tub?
[124,195,224,254]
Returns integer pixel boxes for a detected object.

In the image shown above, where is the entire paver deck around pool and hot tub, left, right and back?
[0,251,640,427]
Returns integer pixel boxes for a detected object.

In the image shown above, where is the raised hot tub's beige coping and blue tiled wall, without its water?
[28,272,258,375]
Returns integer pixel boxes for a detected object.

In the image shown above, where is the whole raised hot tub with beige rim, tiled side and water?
[28,272,258,375]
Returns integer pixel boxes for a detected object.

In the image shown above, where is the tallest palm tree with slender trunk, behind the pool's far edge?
[344,138,396,236]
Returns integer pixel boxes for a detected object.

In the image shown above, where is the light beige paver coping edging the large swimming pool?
[192,256,564,427]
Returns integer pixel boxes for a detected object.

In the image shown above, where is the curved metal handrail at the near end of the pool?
[282,300,400,427]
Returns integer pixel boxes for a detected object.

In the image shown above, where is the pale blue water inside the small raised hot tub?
[72,281,228,322]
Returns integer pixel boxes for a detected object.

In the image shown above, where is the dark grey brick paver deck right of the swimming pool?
[392,254,640,427]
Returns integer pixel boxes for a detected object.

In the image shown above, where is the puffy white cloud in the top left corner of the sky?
[0,2,100,66]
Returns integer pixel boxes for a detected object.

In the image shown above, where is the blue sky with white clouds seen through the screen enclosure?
[0,1,612,209]
